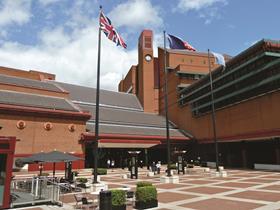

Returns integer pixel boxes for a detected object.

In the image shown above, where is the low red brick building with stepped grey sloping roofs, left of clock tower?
[0,63,190,170]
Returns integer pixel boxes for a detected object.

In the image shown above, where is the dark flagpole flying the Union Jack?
[93,5,102,183]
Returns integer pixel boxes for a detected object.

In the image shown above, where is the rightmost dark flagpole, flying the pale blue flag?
[208,49,219,171]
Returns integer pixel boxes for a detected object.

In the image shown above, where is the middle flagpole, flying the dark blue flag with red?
[163,31,171,176]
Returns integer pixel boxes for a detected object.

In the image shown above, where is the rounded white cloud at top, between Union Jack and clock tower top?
[108,0,163,28]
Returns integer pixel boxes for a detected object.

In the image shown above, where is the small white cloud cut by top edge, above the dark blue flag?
[176,0,227,12]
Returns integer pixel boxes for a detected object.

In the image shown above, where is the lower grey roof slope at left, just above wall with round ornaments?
[0,90,80,112]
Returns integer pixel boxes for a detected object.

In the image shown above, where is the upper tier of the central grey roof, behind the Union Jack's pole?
[48,81,142,110]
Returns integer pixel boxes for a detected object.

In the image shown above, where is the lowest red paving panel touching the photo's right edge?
[227,190,280,202]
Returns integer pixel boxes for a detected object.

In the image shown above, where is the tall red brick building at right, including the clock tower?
[119,30,280,167]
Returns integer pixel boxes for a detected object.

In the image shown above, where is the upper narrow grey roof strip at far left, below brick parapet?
[0,74,63,92]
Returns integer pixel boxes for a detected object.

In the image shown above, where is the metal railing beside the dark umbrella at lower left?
[11,177,71,207]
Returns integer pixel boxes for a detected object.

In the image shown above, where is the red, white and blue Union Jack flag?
[99,12,127,48]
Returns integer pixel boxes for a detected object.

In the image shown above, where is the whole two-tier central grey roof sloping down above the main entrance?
[49,81,191,139]
